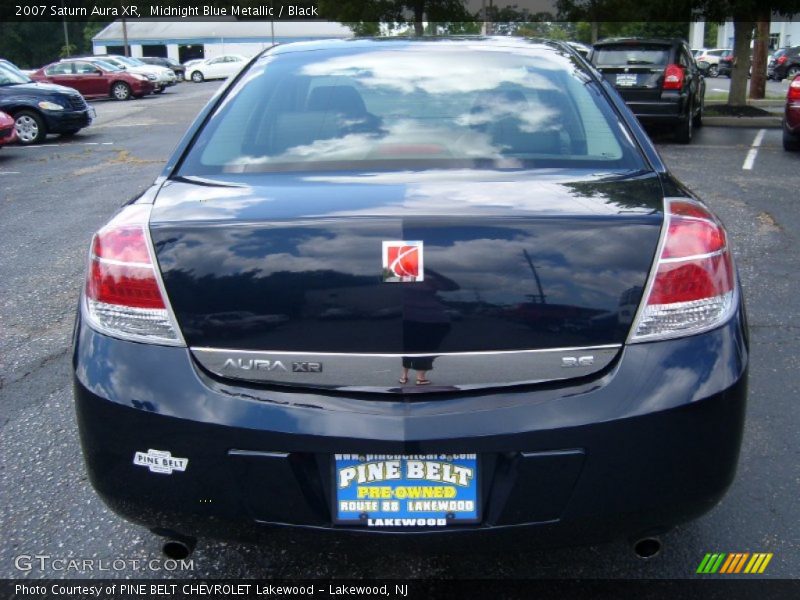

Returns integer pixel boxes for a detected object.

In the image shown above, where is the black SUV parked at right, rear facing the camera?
[589,38,706,144]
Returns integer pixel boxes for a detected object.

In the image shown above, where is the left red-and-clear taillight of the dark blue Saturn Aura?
[85,204,183,345]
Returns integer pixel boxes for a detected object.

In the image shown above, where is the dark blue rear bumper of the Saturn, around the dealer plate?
[74,314,748,545]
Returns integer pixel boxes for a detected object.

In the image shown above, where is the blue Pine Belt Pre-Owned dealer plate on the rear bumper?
[333,454,480,528]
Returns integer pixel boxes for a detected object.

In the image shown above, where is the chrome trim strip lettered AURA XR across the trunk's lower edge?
[190,344,622,394]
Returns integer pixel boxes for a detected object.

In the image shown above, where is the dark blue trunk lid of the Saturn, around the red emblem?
[151,174,663,391]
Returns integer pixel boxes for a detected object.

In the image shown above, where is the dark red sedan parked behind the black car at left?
[31,59,153,100]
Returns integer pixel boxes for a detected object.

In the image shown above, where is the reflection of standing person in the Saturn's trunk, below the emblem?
[398,269,459,385]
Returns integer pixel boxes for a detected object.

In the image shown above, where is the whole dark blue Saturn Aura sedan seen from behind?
[74,38,748,544]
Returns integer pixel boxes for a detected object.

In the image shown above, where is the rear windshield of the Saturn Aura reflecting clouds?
[179,43,642,176]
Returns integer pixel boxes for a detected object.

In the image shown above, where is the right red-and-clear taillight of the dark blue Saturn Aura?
[630,198,736,342]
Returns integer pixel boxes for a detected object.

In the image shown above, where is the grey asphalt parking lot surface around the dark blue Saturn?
[0,83,800,578]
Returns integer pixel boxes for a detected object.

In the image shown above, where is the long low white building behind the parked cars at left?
[92,19,352,62]
